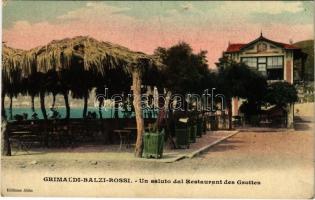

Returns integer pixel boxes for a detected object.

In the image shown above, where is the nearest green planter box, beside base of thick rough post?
[143,123,165,159]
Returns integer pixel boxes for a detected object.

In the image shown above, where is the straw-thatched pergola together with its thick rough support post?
[3,36,163,157]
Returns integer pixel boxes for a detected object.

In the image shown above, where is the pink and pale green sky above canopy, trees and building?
[2,0,314,67]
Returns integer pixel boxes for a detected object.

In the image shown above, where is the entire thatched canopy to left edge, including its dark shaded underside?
[2,36,167,99]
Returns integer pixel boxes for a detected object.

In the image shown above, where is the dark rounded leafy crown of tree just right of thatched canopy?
[154,42,209,94]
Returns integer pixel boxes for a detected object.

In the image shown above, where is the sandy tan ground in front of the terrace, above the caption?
[2,131,314,172]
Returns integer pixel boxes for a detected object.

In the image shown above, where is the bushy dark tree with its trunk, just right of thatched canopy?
[154,42,213,145]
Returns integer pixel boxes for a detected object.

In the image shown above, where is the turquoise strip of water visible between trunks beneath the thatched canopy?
[6,107,157,119]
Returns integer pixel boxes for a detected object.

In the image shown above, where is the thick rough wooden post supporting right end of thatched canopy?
[132,68,144,158]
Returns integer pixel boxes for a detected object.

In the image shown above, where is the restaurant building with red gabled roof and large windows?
[223,34,306,126]
